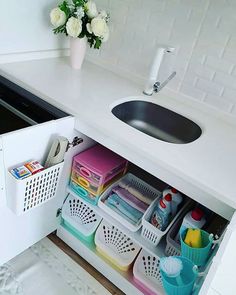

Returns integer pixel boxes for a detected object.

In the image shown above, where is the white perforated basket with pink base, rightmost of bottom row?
[133,249,163,294]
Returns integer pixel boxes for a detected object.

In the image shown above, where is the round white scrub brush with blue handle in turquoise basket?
[160,256,184,286]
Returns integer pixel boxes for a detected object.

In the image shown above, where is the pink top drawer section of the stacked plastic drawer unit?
[73,145,128,188]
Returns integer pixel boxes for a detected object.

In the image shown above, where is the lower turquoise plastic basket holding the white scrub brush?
[160,256,198,295]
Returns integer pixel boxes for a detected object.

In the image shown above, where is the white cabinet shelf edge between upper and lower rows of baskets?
[67,187,166,257]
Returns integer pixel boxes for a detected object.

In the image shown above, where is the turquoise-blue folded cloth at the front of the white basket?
[105,193,143,224]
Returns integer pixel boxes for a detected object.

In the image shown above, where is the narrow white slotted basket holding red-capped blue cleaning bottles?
[141,199,189,246]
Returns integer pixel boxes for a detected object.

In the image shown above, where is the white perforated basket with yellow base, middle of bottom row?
[95,220,141,271]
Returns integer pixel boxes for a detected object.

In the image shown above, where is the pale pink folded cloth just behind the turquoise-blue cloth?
[112,185,148,213]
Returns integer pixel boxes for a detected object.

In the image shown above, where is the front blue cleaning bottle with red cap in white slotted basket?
[150,194,172,231]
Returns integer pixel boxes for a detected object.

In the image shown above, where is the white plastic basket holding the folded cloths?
[98,173,160,232]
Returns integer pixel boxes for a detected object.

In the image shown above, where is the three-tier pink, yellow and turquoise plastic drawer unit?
[70,144,128,204]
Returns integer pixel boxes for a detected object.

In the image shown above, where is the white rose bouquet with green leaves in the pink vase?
[50,0,109,49]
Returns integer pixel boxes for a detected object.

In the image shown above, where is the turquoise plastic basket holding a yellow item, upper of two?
[180,229,213,266]
